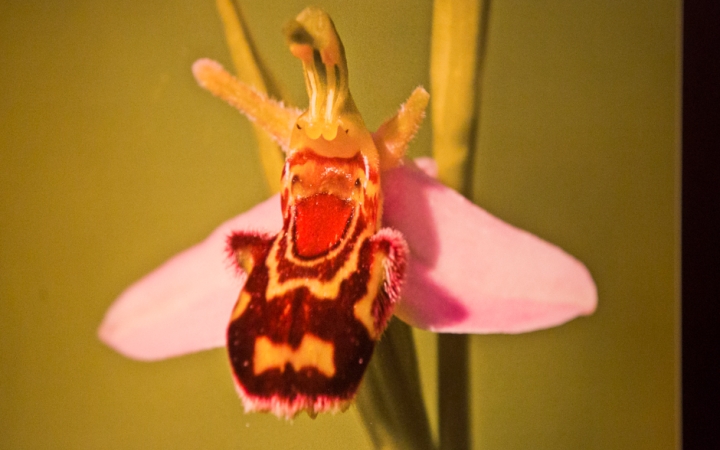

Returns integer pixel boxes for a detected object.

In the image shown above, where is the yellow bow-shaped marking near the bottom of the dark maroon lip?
[253,334,335,377]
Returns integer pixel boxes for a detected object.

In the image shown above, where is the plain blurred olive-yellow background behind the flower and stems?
[0,0,680,449]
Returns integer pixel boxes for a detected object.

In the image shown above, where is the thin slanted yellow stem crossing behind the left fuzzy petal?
[216,0,284,193]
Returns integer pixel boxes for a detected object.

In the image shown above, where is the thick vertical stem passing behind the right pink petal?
[430,0,483,450]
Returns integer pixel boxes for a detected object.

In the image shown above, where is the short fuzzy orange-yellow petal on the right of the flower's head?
[373,87,430,170]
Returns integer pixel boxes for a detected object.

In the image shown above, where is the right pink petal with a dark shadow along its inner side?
[383,166,597,333]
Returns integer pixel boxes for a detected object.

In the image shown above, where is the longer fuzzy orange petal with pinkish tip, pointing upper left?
[192,59,300,151]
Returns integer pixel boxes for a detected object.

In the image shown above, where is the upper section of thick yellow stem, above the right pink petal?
[430,0,481,191]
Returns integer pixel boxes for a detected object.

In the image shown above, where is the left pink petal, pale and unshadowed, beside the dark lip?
[98,195,282,360]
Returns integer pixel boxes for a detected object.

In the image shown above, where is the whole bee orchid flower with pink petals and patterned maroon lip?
[99,8,597,417]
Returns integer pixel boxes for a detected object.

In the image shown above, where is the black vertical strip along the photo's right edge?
[681,0,720,449]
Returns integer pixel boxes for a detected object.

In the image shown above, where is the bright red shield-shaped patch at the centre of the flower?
[294,194,353,258]
